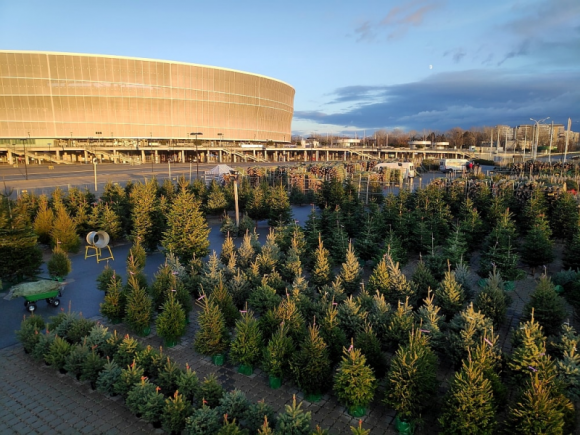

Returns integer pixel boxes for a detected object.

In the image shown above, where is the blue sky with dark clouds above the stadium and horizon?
[0,0,580,136]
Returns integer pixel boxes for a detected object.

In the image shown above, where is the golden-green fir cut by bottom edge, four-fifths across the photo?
[439,359,497,435]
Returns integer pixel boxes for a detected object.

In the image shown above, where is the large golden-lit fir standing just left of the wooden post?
[161,188,210,263]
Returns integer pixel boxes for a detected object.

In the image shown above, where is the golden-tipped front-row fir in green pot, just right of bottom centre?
[334,340,377,417]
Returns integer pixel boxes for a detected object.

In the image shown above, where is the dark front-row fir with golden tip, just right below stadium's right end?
[290,325,332,394]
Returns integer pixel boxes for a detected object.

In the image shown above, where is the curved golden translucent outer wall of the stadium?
[0,51,294,142]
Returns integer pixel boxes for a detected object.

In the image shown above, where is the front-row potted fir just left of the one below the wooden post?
[193,293,229,356]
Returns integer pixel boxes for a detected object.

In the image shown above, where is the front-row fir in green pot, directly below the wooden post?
[230,305,262,376]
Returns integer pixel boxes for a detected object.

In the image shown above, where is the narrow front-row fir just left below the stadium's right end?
[263,323,294,389]
